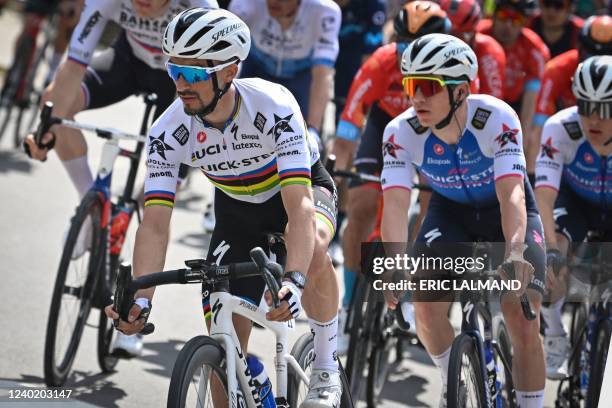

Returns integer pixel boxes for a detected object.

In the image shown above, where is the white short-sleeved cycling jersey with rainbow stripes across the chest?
[145,78,319,207]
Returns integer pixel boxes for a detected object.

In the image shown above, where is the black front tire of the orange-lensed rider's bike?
[446,333,488,408]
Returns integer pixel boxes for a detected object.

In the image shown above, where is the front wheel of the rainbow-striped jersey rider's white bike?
[168,336,230,408]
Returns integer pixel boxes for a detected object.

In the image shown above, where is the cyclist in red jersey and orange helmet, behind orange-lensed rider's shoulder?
[332,1,451,352]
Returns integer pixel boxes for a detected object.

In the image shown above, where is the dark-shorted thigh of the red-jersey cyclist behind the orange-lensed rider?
[349,104,391,190]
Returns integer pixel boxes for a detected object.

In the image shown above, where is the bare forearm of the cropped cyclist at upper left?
[42,61,86,117]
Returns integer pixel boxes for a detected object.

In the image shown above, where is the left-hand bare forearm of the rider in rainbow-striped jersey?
[133,221,169,299]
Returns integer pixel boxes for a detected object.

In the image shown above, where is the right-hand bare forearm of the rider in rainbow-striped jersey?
[281,185,316,274]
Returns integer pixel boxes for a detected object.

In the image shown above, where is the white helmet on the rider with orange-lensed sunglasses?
[400,34,478,81]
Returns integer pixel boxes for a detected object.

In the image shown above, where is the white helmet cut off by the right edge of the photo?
[572,55,612,102]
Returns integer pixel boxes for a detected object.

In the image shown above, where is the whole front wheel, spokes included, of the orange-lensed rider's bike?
[446,333,488,408]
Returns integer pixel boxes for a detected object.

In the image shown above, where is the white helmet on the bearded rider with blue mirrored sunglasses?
[162,7,251,61]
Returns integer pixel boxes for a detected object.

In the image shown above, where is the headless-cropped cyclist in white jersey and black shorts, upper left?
[26,0,216,355]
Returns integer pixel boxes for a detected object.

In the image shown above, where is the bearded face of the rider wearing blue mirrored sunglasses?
[170,57,238,115]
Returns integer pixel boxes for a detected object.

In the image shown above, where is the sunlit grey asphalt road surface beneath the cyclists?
[0,7,556,408]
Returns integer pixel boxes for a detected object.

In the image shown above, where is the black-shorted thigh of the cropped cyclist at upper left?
[83,33,137,109]
